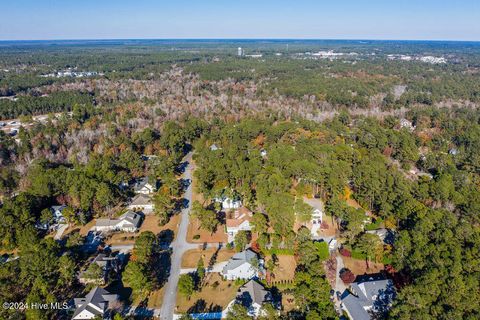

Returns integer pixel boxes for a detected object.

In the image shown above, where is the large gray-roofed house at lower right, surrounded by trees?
[341,277,396,320]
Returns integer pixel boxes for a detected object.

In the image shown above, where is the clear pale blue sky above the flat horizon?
[0,0,480,41]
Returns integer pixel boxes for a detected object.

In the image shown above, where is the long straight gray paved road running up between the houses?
[160,152,198,320]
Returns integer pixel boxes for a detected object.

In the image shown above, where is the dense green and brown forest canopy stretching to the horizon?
[0,40,480,320]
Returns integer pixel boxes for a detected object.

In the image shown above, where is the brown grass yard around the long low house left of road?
[105,215,180,245]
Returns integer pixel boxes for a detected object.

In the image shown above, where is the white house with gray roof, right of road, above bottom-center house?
[220,249,260,280]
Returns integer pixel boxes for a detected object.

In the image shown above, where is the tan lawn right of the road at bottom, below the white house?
[176,273,240,313]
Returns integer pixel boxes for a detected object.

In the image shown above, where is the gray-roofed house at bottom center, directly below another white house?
[234,280,272,318]
